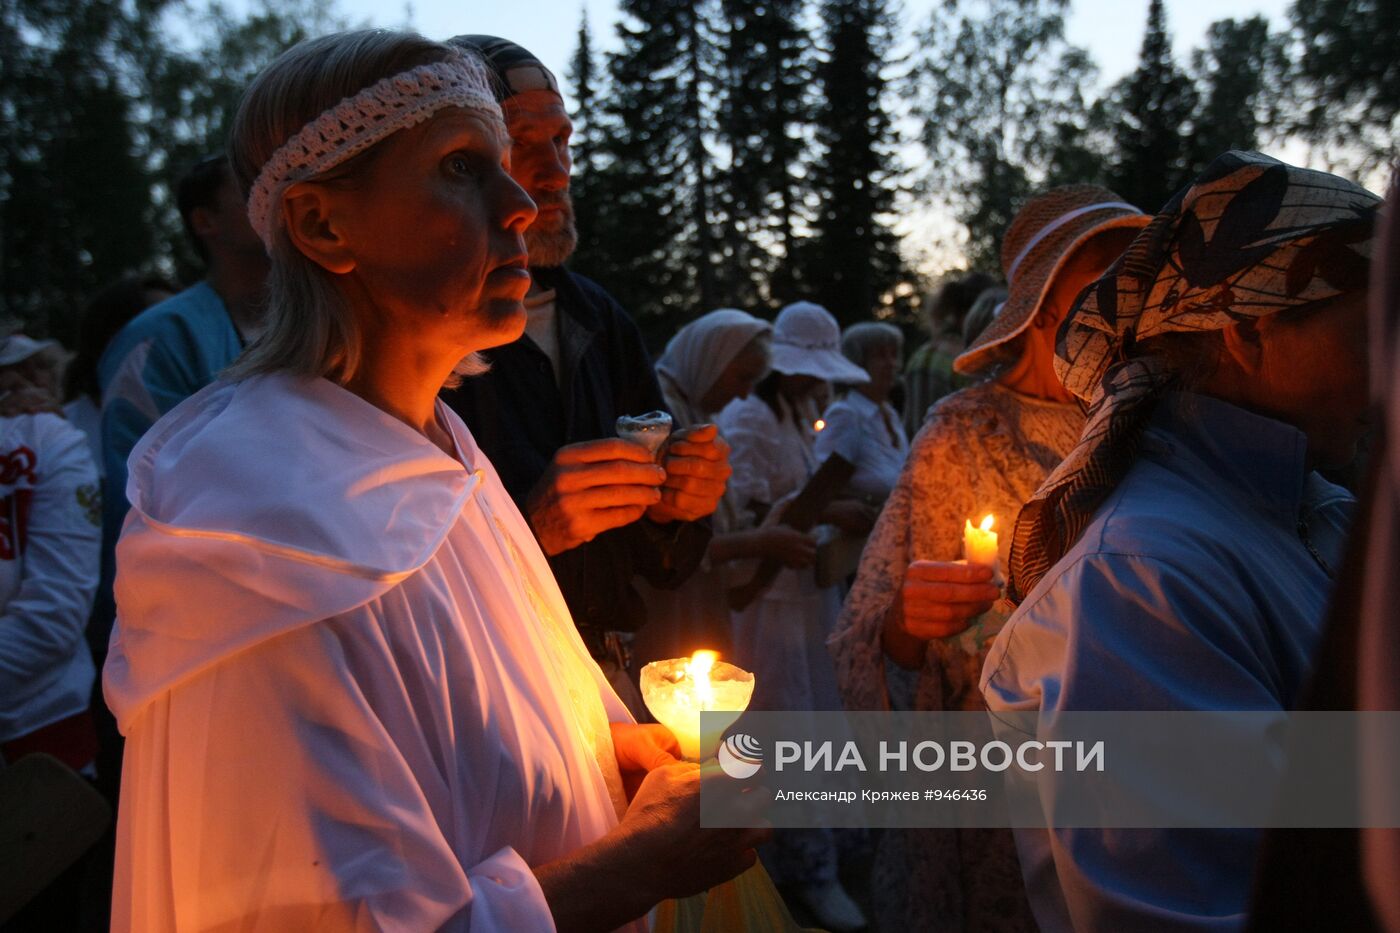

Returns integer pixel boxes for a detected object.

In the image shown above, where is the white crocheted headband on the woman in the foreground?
[248,56,501,246]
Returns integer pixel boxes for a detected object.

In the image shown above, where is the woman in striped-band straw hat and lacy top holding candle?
[830,185,1148,930]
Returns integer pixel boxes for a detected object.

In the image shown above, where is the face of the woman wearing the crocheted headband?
[328,108,535,356]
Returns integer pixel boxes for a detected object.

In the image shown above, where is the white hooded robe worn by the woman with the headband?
[105,375,644,933]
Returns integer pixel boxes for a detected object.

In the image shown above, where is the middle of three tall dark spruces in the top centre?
[718,0,812,308]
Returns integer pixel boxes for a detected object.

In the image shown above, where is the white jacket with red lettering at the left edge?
[0,415,102,742]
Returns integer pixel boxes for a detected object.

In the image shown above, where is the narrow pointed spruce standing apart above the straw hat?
[1109,0,1198,213]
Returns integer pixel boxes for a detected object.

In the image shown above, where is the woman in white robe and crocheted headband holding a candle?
[105,31,759,933]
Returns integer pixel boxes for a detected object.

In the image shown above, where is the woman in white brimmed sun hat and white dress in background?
[720,301,869,930]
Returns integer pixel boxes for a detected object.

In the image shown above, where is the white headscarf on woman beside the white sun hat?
[657,308,773,427]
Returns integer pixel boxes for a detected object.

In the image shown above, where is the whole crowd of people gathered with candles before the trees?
[0,19,1400,932]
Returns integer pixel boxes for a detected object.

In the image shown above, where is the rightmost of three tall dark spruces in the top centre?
[802,0,906,324]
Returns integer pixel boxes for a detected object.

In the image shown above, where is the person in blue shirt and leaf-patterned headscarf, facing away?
[983,153,1379,932]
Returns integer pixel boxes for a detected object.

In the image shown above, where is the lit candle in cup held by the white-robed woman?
[641,651,753,761]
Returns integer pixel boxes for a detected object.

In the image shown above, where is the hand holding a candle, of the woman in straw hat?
[883,560,1001,670]
